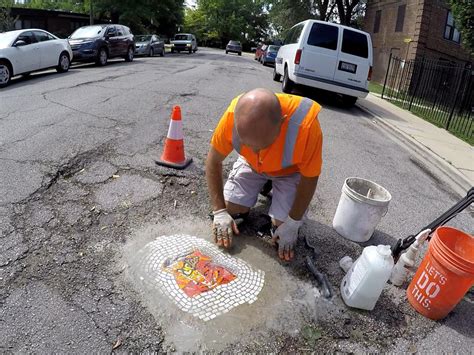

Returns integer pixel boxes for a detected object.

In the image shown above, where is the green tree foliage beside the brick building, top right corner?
[448,0,474,55]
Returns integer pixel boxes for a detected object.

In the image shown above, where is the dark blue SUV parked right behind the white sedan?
[69,24,135,65]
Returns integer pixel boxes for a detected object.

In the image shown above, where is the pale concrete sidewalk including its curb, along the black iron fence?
[357,94,474,195]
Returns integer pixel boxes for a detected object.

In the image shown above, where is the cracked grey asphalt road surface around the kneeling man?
[0,49,474,353]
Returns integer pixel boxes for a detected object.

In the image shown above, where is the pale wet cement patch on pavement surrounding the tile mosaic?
[123,220,332,352]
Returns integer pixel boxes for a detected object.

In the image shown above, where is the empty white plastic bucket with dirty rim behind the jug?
[332,177,392,242]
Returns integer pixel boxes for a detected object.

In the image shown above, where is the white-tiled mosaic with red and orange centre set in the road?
[137,235,265,321]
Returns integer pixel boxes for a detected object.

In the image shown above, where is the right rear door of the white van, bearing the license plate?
[334,28,372,89]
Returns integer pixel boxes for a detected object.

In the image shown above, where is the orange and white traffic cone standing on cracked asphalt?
[156,106,193,170]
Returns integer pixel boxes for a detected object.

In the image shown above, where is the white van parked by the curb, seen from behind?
[273,20,372,105]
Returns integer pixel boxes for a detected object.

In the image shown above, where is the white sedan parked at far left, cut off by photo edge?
[0,29,72,87]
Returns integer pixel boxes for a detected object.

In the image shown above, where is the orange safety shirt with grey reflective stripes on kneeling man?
[211,94,323,177]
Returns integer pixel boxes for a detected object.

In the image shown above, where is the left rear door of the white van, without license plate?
[296,22,339,80]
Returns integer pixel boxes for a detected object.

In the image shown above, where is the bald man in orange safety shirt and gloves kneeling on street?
[206,89,323,261]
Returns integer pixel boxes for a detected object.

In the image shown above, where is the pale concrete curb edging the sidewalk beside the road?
[356,103,472,197]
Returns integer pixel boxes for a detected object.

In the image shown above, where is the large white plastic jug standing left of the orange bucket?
[341,245,393,311]
